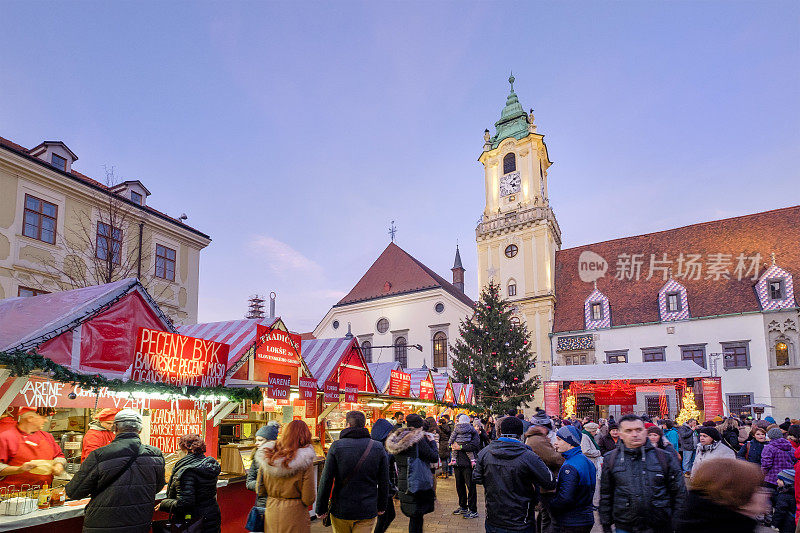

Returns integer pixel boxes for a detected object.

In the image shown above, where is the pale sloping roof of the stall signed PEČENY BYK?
[0,278,175,351]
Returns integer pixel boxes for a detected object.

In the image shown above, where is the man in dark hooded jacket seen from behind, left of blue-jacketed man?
[472,416,555,533]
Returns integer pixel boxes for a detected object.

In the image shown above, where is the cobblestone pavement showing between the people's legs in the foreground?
[311,477,602,533]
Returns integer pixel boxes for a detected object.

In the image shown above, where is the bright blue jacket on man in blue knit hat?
[547,442,597,527]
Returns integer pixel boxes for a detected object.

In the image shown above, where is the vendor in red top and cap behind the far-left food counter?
[0,407,66,489]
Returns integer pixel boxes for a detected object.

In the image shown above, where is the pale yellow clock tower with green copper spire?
[475,74,561,407]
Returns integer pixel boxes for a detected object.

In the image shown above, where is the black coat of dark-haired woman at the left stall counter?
[159,453,222,533]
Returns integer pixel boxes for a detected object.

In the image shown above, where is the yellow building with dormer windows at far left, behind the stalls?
[0,138,211,325]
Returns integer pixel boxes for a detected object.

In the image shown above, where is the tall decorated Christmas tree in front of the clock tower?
[451,281,539,413]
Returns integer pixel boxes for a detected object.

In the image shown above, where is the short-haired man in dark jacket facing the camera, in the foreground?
[600,415,686,533]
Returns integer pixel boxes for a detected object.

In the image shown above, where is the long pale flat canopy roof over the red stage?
[550,361,711,381]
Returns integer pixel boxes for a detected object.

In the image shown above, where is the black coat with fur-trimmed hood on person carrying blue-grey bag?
[386,427,440,517]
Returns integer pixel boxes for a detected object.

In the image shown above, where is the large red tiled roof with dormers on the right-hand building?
[553,206,800,332]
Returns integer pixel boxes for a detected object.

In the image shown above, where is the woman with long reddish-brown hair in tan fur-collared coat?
[257,420,317,533]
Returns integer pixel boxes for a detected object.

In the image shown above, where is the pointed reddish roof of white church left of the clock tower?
[336,243,475,306]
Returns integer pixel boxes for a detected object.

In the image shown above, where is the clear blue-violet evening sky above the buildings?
[0,0,800,331]
